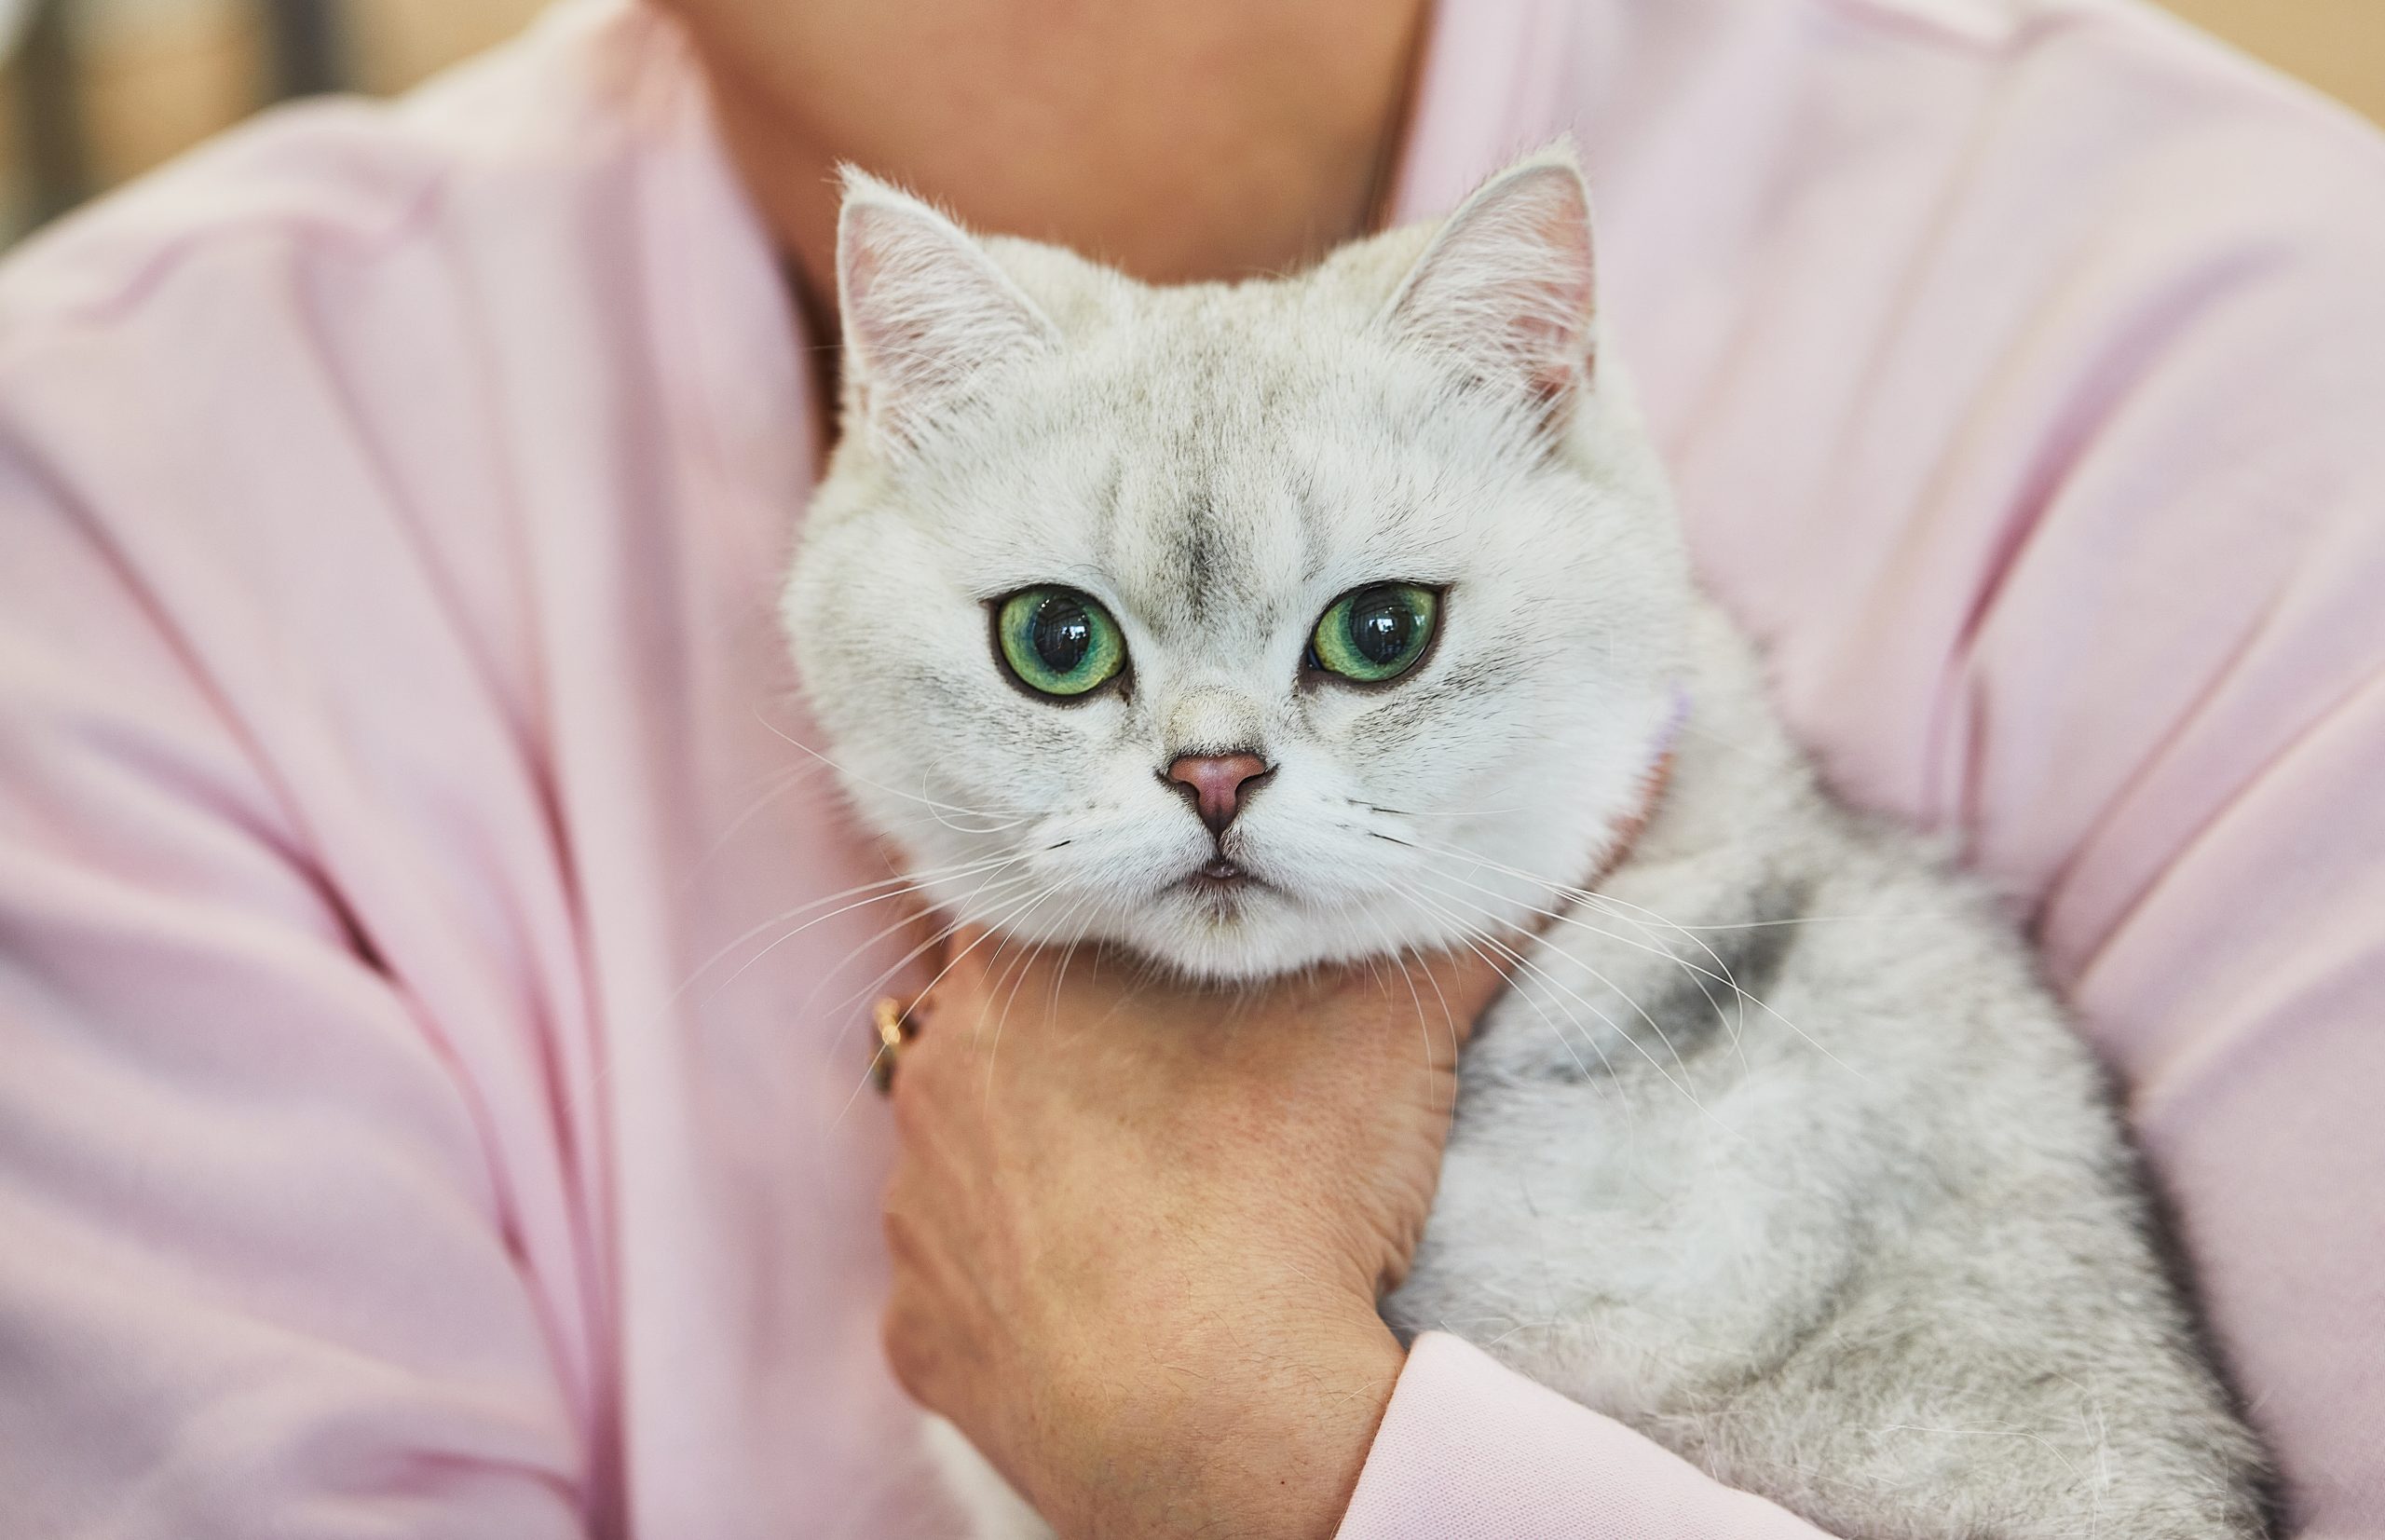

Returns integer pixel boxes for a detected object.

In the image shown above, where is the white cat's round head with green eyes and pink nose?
[784,150,1688,977]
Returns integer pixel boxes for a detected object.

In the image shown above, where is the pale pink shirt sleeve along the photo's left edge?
[0,448,587,1540]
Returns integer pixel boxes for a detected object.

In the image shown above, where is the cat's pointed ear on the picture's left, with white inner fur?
[838,167,1059,451]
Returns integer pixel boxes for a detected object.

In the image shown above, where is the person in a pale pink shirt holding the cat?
[0,0,2385,1540]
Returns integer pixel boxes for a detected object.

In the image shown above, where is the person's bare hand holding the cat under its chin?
[885,933,1500,1540]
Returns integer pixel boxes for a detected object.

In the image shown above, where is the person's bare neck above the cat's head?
[687,0,1428,352]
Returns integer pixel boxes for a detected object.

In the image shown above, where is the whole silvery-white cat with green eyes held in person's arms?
[783,145,2266,1540]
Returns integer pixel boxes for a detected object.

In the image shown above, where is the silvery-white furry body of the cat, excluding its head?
[1385,603,2258,1537]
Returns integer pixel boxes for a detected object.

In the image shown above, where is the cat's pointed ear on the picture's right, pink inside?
[1388,143,1598,427]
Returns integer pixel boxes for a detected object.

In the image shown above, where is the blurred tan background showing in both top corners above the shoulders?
[0,0,2385,246]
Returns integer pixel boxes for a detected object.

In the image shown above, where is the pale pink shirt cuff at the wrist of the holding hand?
[1338,1332,1822,1540]
